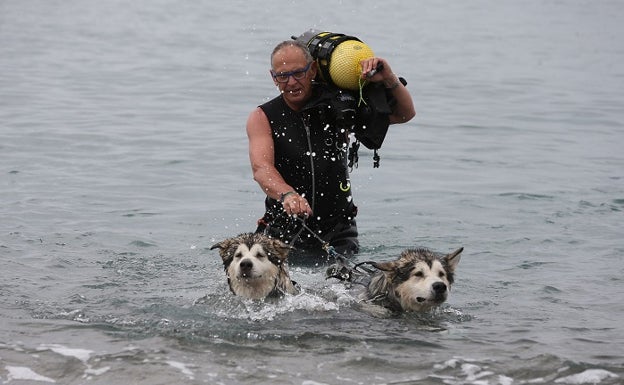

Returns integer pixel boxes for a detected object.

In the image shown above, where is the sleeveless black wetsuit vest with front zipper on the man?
[260,87,356,238]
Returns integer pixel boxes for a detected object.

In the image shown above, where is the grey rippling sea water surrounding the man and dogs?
[0,0,624,385]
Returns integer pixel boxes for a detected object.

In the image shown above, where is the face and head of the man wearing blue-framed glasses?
[271,46,316,111]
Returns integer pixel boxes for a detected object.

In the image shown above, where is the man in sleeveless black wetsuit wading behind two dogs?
[247,40,416,255]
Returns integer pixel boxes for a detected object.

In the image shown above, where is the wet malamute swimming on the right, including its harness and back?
[327,247,464,312]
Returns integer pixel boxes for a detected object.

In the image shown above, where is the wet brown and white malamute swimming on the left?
[210,233,298,299]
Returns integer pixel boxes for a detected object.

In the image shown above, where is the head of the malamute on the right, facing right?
[373,248,464,311]
